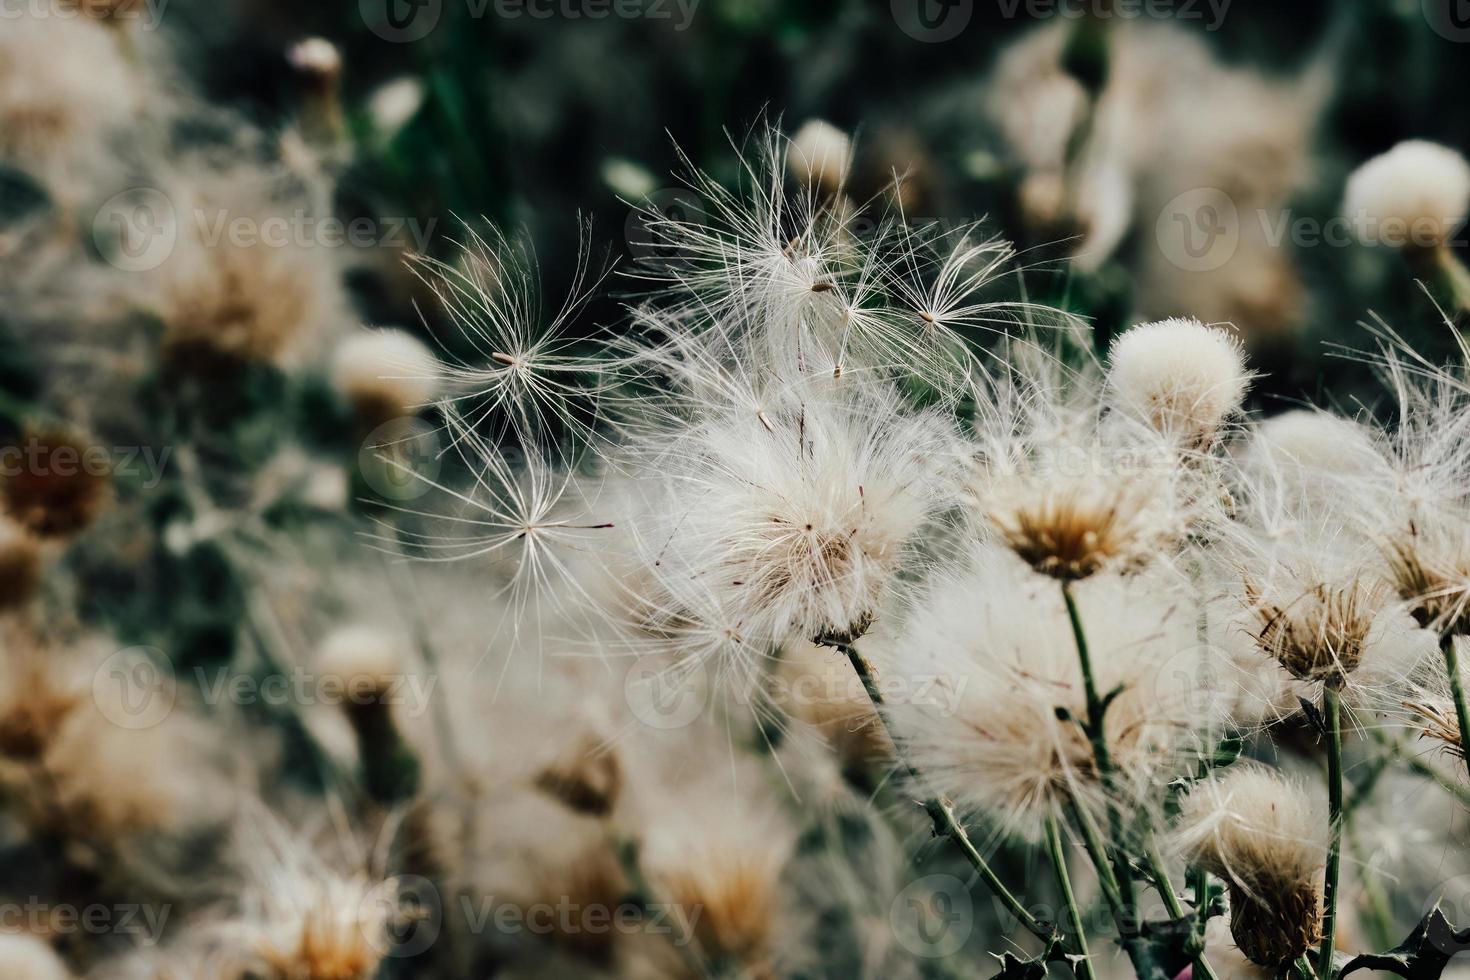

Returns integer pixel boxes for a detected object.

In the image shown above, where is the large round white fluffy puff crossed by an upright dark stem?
[879,548,1225,840]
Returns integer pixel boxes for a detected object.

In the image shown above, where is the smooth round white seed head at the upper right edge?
[1342,140,1470,248]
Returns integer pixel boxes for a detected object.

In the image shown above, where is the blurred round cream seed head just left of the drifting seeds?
[332,329,441,419]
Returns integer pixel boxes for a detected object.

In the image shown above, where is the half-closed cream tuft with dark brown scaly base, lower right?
[1177,763,1327,967]
